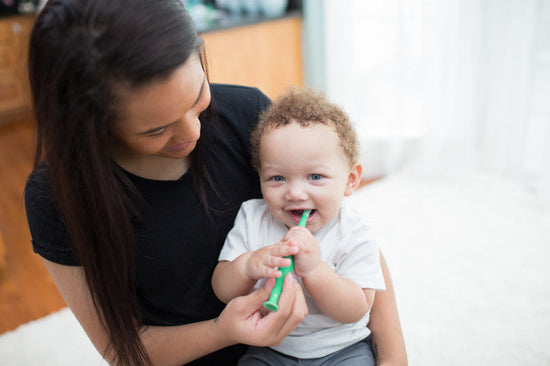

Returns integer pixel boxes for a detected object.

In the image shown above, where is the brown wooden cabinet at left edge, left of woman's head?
[0,16,34,121]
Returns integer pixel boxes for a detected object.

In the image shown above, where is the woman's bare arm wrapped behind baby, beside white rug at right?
[368,253,408,366]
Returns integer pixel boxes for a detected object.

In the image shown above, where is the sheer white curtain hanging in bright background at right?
[305,0,550,203]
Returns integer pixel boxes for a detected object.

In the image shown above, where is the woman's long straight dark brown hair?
[29,0,206,365]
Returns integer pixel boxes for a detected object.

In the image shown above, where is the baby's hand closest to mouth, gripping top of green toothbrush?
[283,226,321,277]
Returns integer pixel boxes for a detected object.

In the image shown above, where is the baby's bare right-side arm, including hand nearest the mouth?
[285,227,375,323]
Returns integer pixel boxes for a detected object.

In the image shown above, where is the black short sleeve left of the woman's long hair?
[25,167,78,266]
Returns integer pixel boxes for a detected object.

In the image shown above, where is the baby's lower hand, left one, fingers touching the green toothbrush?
[245,242,299,280]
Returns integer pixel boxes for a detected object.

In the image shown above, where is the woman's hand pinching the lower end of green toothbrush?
[216,274,307,347]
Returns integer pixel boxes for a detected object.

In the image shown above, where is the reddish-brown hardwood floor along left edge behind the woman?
[0,116,65,334]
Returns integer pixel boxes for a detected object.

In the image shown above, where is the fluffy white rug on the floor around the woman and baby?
[0,173,550,366]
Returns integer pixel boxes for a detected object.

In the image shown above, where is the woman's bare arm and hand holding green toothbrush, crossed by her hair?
[44,260,307,365]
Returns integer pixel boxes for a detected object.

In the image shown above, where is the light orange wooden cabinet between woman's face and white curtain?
[201,16,303,99]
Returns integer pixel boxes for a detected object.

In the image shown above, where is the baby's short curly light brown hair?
[250,87,359,171]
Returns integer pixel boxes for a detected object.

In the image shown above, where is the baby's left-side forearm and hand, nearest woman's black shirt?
[212,243,298,303]
